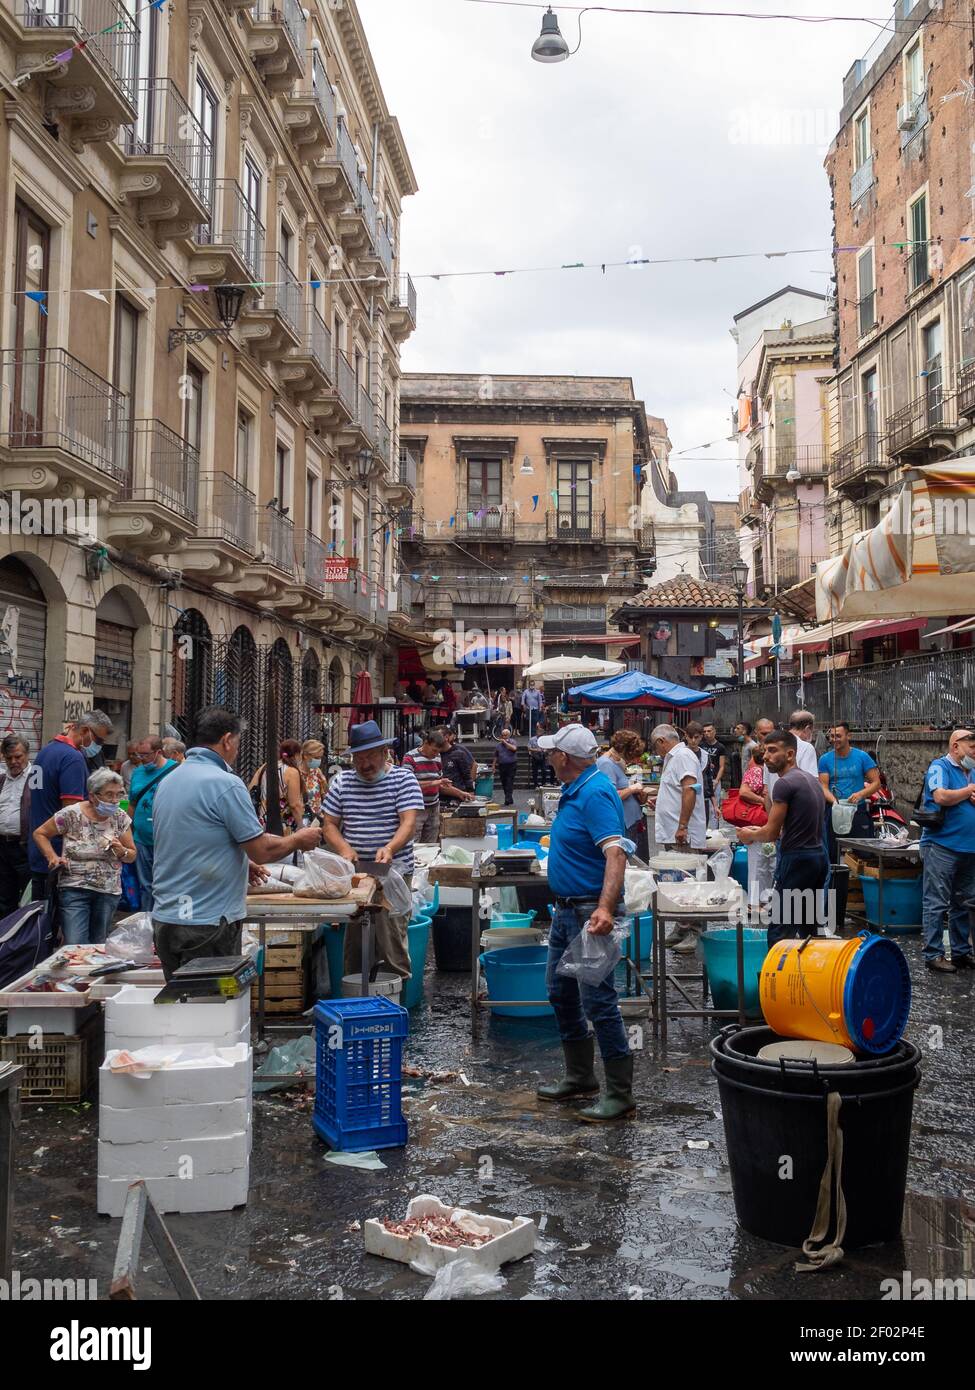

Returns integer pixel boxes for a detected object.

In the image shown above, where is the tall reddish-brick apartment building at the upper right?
[826,0,975,553]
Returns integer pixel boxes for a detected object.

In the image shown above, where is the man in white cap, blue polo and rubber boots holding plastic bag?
[537,724,636,1123]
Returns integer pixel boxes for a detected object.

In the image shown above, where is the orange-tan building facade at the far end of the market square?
[401,373,669,684]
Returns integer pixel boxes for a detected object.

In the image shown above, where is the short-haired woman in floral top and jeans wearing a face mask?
[33,767,135,947]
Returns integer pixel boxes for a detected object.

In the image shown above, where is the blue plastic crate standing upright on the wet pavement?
[312,995,409,1152]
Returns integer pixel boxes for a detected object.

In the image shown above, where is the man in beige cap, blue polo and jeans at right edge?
[921,728,975,974]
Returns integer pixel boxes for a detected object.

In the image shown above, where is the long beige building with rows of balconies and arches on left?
[0,0,416,772]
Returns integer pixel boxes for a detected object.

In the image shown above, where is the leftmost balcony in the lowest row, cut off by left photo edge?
[0,348,128,496]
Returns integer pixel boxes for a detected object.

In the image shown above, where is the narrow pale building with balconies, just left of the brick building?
[725,286,833,596]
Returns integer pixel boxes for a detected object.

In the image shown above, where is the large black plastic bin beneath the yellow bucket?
[711,1026,921,1250]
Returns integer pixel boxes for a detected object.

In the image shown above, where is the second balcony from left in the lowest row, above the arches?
[106,420,200,555]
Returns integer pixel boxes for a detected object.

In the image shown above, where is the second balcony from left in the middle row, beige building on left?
[117,78,214,246]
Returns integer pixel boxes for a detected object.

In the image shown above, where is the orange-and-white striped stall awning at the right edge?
[816,457,975,623]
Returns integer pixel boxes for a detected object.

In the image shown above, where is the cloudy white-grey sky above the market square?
[359,0,889,498]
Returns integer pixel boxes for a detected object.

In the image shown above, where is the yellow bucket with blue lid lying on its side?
[759,933,911,1054]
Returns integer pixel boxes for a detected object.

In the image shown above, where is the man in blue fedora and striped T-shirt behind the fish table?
[323,719,423,980]
